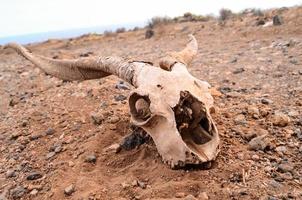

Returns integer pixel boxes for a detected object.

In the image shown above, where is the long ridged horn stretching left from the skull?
[5,43,137,85]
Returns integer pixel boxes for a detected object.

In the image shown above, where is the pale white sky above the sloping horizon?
[0,0,302,38]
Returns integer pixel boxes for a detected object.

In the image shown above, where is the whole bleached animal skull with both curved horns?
[7,35,219,167]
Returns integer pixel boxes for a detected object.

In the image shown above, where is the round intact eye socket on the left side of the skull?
[129,93,151,122]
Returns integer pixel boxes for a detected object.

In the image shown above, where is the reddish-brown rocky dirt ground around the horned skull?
[0,7,302,200]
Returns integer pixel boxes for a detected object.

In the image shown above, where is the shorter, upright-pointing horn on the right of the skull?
[159,34,198,71]
